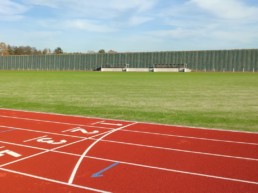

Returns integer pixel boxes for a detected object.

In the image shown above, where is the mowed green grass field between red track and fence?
[0,71,258,131]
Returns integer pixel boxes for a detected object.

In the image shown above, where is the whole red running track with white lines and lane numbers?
[0,109,258,193]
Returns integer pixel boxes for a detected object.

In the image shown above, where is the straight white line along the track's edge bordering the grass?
[0,108,258,135]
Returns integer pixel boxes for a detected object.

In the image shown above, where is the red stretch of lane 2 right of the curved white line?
[101,129,258,161]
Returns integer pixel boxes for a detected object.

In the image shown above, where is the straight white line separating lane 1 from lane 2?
[0,115,258,145]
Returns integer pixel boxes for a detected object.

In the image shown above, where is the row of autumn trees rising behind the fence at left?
[0,42,117,56]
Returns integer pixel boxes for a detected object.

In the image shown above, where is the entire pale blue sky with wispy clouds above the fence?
[0,0,258,52]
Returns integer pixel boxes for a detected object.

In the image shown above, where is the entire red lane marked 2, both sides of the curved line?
[0,114,258,159]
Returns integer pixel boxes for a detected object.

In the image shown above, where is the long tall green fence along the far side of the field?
[0,49,258,72]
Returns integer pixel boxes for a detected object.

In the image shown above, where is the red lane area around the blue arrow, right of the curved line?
[71,158,258,193]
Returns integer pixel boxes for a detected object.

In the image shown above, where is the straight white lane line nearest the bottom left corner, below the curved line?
[0,168,109,193]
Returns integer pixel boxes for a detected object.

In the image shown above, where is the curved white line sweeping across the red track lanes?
[68,122,137,184]
